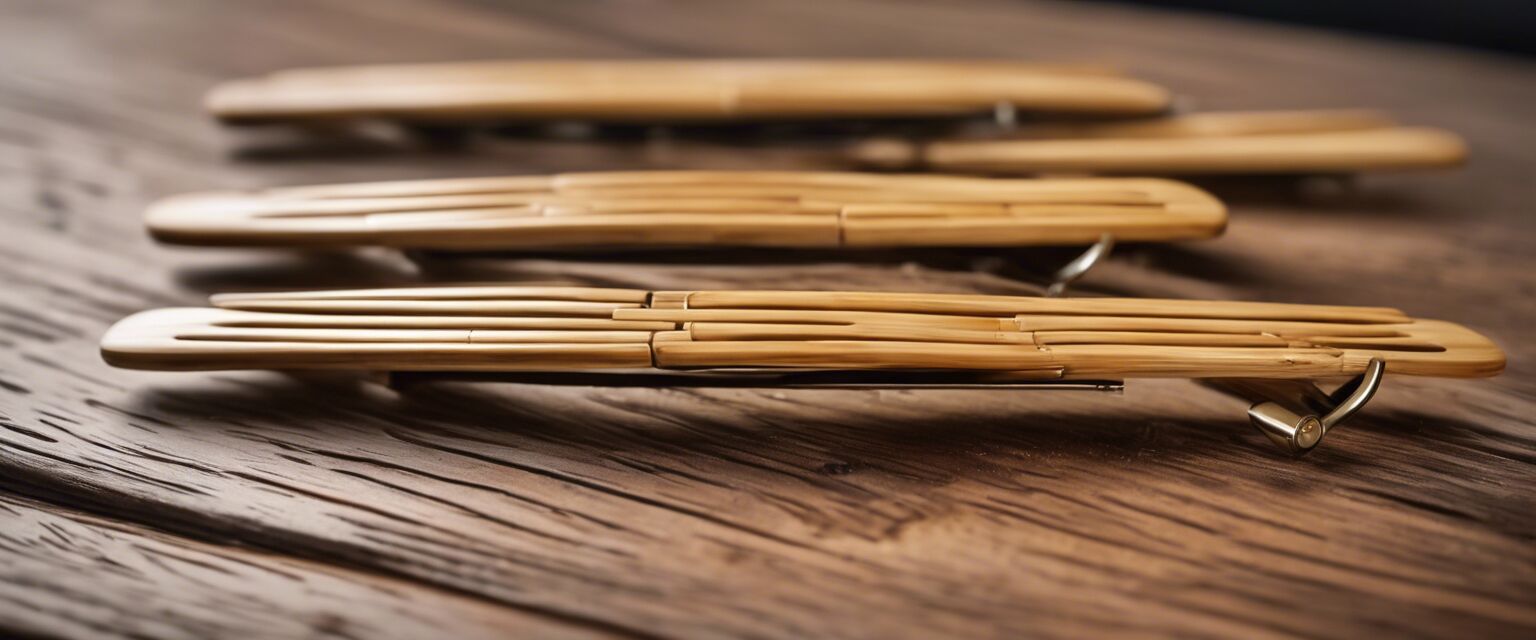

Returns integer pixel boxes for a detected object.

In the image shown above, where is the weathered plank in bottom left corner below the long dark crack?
[0,496,610,638]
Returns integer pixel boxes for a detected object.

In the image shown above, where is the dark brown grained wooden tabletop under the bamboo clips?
[0,0,1536,637]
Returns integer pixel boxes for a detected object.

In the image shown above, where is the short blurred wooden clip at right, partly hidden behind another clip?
[852,111,1467,175]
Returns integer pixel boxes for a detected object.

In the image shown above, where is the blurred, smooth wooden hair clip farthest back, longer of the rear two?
[206,60,1169,123]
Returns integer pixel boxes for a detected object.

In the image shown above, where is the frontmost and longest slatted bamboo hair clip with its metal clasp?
[101,285,1504,453]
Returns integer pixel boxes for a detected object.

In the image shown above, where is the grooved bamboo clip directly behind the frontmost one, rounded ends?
[144,170,1227,250]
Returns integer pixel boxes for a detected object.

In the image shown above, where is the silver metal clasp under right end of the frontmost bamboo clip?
[1206,358,1387,456]
